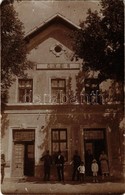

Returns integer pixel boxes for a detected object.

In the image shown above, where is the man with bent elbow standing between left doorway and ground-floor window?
[40,150,52,181]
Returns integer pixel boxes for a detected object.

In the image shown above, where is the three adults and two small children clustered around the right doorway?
[72,150,109,182]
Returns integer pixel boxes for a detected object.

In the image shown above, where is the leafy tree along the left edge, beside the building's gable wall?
[1,0,32,104]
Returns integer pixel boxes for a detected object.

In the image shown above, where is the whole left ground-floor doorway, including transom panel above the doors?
[12,130,35,177]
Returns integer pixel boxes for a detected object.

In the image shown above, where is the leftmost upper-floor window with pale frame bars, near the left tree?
[18,79,33,103]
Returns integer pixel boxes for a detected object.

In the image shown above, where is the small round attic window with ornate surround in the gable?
[50,43,66,57]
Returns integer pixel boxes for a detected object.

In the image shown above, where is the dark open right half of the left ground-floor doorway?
[24,142,35,176]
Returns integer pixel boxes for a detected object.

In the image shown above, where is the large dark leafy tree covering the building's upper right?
[73,0,124,82]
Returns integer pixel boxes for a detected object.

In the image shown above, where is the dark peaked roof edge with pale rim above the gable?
[25,13,80,40]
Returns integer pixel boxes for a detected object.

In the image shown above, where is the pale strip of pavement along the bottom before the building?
[1,179,125,195]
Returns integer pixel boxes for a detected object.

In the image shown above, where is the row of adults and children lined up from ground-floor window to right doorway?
[40,150,109,182]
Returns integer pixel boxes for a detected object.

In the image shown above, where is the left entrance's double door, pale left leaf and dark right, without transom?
[12,141,35,177]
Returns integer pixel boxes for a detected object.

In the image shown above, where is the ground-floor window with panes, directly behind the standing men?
[51,129,68,161]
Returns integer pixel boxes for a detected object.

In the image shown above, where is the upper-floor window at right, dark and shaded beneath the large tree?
[85,79,101,104]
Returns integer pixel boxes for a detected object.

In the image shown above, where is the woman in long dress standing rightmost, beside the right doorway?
[99,151,109,179]
